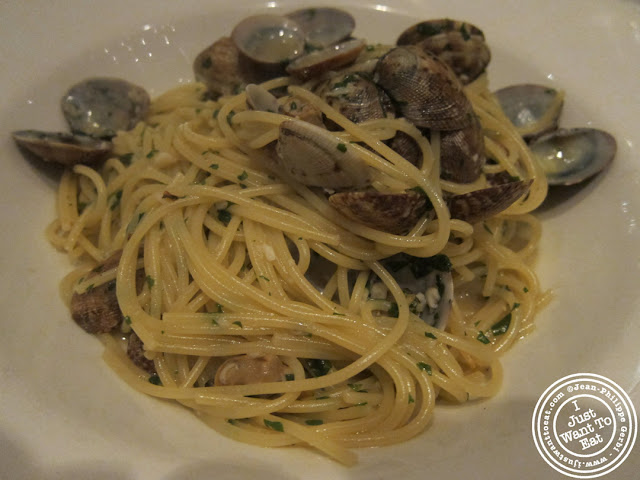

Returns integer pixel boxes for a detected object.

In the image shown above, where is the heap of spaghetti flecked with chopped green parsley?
[47,61,549,465]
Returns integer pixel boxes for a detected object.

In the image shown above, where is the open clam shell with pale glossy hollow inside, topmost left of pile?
[231,15,305,65]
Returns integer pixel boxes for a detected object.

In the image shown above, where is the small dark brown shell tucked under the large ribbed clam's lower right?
[440,115,486,183]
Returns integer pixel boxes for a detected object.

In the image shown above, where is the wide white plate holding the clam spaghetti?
[0,0,640,480]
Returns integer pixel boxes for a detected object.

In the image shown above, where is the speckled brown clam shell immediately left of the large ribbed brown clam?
[314,73,393,123]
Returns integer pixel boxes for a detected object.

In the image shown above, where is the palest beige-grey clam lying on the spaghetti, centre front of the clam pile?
[275,120,370,189]
